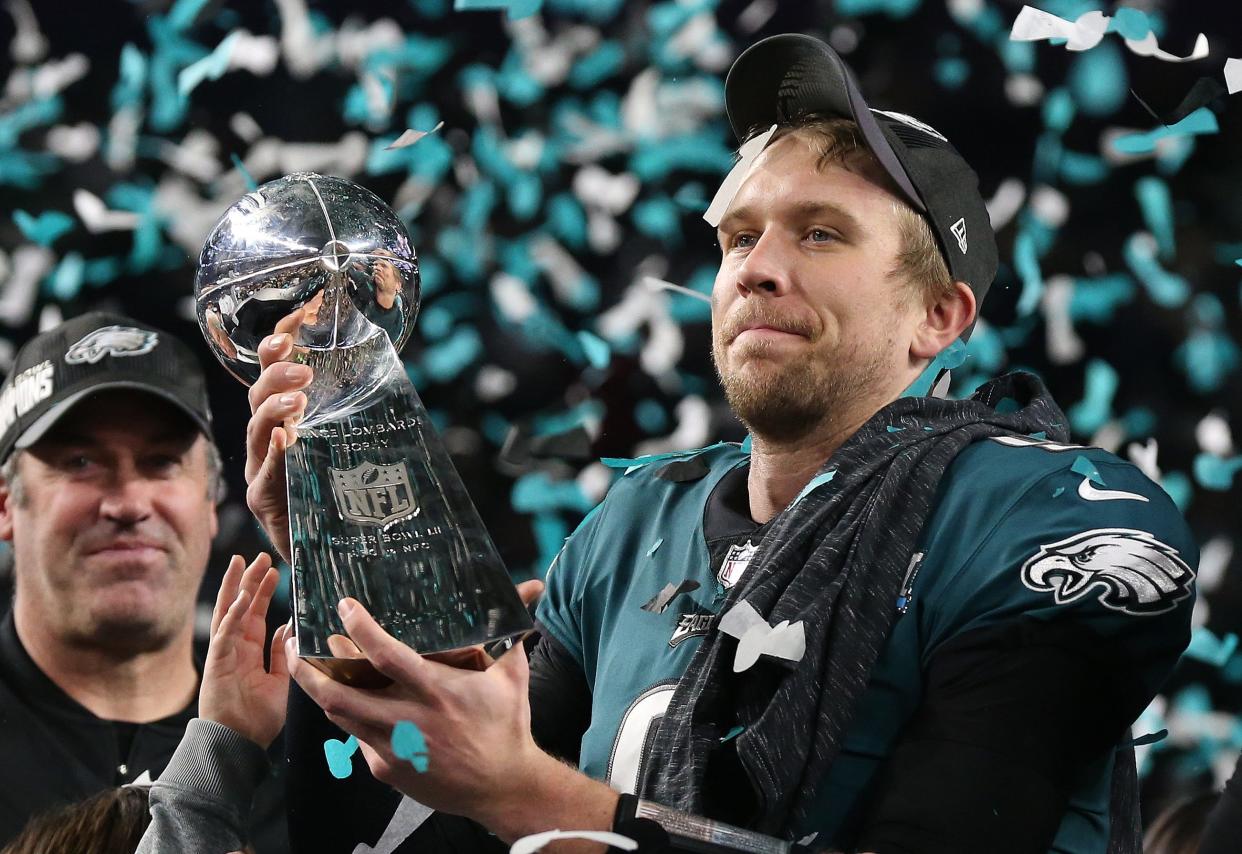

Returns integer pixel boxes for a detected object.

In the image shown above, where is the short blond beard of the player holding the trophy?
[712,332,889,442]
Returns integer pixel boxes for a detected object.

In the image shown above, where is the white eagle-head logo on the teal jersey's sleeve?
[1022,528,1195,614]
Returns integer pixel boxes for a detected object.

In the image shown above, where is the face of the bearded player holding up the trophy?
[712,132,923,441]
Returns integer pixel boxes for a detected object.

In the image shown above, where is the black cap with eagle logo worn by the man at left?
[0,312,211,462]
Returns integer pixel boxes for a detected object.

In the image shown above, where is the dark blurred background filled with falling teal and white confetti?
[0,0,1242,829]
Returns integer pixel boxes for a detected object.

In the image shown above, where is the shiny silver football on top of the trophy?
[194,173,420,385]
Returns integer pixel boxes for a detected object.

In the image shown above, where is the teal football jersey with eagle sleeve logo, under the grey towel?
[538,437,1199,853]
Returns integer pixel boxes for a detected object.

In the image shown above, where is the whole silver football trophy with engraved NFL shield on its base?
[195,173,532,681]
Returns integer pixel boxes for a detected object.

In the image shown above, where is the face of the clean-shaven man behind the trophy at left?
[0,391,216,653]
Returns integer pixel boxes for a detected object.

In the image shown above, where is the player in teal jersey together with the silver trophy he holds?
[155,30,1196,852]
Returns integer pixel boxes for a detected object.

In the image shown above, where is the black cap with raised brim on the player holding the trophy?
[724,34,996,327]
